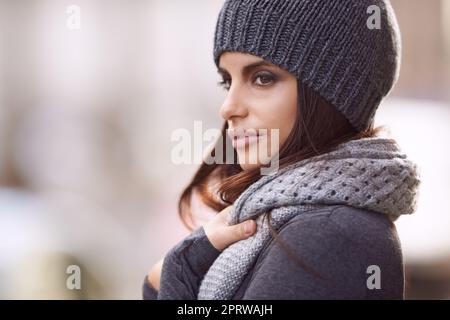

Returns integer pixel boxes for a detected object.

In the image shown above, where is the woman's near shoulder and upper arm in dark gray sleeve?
[246,205,404,299]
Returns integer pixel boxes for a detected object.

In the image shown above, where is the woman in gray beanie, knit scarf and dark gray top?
[144,0,419,299]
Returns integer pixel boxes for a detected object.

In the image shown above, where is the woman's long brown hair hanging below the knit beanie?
[178,82,382,277]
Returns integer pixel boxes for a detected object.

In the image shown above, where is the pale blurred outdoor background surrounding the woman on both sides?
[0,0,450,299]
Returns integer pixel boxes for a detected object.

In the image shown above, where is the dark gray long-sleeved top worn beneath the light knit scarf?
[143,205,404,300]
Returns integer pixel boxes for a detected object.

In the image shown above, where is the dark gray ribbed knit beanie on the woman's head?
[214,0,401,131]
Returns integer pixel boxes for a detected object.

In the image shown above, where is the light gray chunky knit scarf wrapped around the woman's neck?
[198,138,420,300]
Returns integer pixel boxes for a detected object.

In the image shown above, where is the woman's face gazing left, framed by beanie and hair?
[218,51,297,170]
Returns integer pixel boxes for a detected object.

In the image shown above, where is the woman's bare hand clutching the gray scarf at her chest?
[203,206,256,251]
